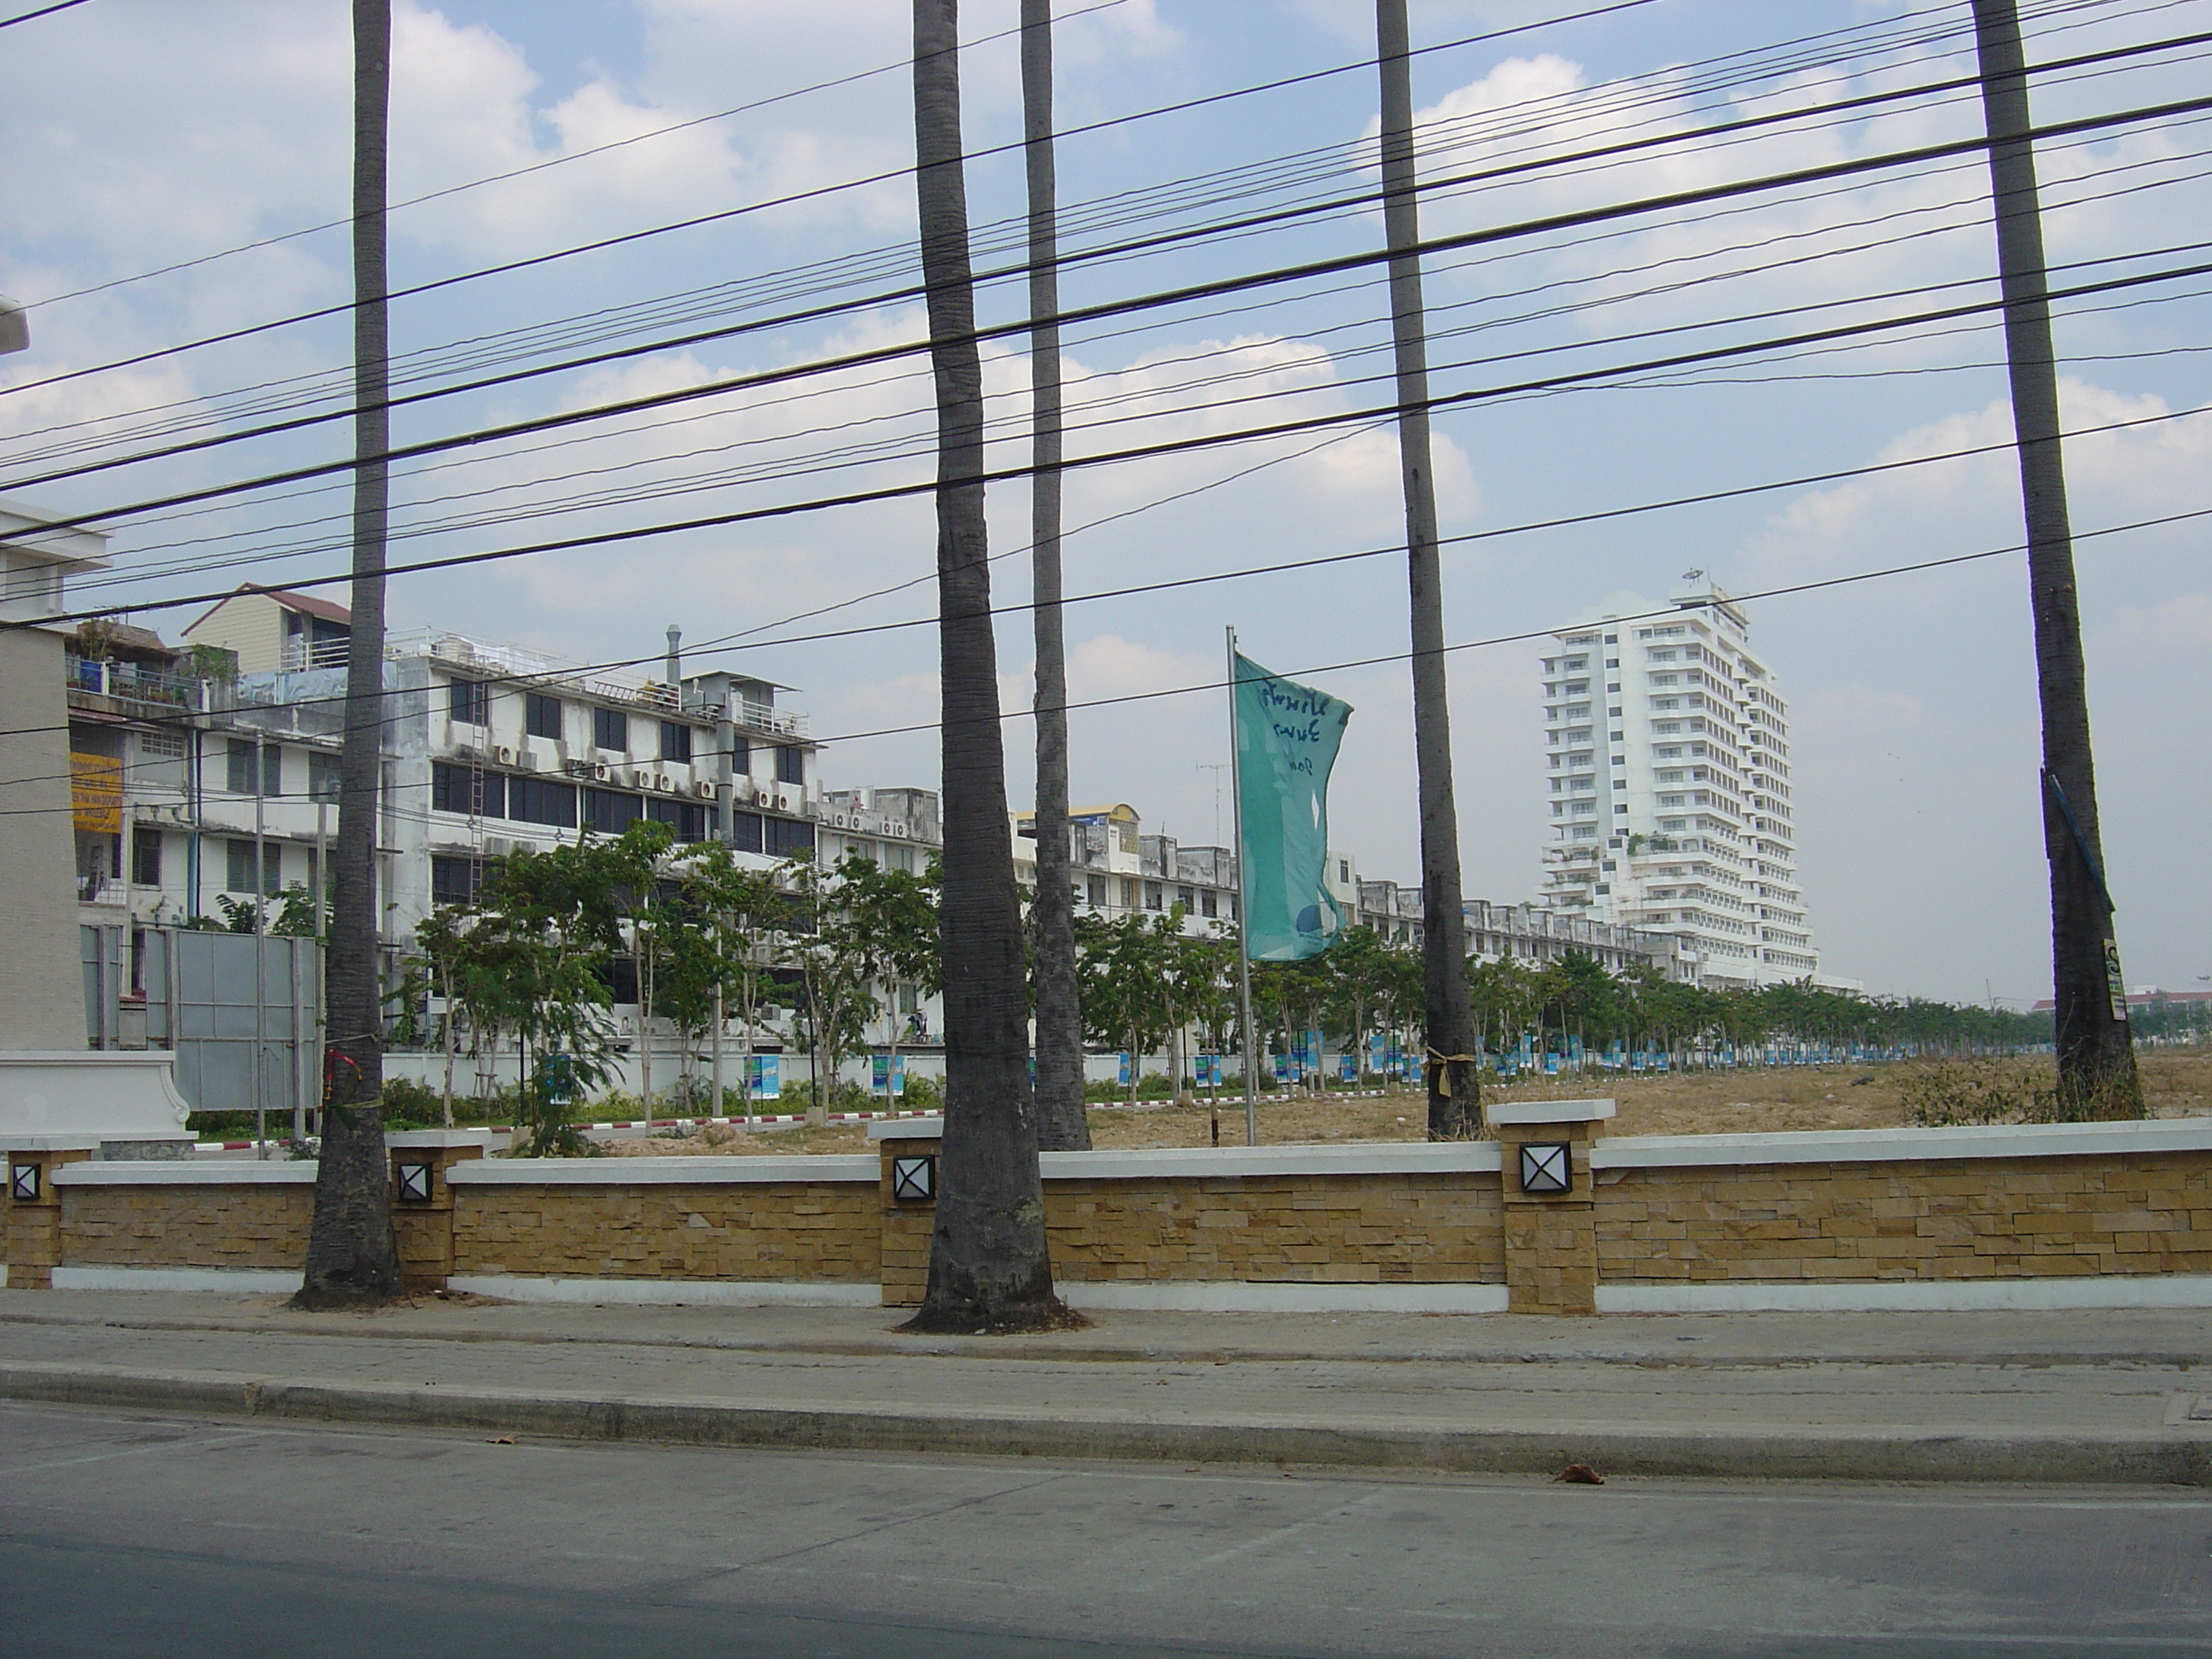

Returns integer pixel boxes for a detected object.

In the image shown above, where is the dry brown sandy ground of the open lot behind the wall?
[608,1049,2212,1157]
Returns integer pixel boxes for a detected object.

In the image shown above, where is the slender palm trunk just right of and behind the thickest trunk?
[1022,0,1091,1152]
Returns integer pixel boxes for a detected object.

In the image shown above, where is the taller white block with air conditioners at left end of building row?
[64,588,825,973]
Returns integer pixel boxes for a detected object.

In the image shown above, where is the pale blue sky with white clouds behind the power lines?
[0,0,2212,1002]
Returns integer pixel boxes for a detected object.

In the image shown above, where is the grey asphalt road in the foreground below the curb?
[0,1405,2212,1659]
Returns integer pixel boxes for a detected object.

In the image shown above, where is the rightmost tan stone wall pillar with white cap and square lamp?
[1484,1099,1615,1314]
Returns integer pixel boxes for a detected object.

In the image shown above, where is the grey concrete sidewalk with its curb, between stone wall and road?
[0,1292,2212,1484]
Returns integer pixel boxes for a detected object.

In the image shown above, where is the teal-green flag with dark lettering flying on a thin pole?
[1234,653,1352,963]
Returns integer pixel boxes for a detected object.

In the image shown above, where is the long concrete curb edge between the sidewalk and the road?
[0,1363,2212,1487]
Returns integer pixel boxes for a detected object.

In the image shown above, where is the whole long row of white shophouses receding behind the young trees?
[67,588,1688,1044]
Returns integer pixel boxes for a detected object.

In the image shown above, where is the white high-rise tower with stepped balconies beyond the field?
[1544,571,1820,984]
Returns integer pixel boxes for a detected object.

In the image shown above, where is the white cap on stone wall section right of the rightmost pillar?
[1591,1117,2212,1170]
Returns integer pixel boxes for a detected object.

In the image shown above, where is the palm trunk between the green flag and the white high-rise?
[1376,0,1482,1139]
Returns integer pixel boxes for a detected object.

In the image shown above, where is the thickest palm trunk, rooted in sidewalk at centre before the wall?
[907,0,1081,1331]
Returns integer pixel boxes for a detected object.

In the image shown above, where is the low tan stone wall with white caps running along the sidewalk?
[7,1120,2212,1312]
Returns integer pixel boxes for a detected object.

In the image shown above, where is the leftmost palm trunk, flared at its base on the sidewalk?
[292,0,400,1307]
